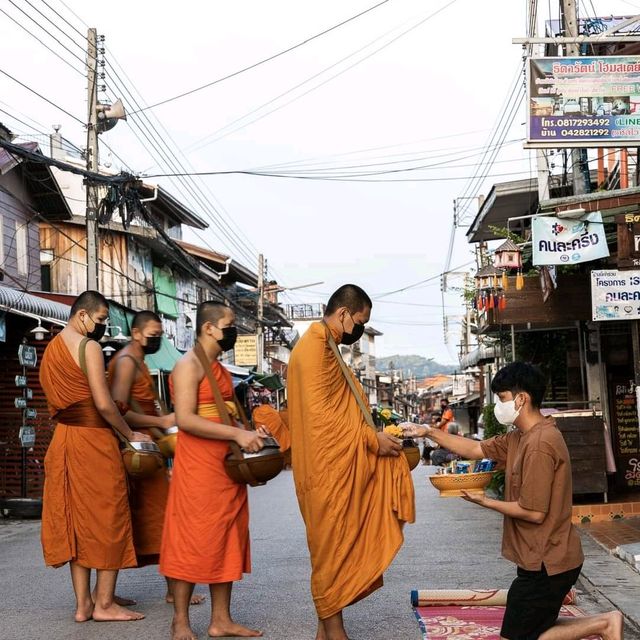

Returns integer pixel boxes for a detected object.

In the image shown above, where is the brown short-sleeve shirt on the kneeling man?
[480,418,584,575]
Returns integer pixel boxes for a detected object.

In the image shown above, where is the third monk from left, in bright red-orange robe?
[160,302,263,640]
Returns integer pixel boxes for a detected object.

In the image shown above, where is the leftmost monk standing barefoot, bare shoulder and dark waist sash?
[40,291,149,622]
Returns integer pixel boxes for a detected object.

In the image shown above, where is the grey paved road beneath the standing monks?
[0,467,629,640]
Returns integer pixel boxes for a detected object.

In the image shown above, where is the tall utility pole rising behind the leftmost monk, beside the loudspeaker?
[86,29,100,291]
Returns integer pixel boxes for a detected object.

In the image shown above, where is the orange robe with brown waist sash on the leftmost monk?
[40,335,136,569]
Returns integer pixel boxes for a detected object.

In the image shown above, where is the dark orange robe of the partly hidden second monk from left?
[109,351,169,566]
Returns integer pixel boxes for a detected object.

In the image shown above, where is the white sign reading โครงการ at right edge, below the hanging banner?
[591,269,640,320]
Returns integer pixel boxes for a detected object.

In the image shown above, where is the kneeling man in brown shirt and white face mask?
[405,362,622,640]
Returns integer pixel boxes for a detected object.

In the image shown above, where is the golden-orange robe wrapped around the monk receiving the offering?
[288,323,415,619]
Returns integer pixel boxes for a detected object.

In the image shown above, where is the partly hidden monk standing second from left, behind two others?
[109,311,204,604]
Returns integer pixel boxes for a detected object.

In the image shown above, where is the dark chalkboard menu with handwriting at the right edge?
[611,379,640,487]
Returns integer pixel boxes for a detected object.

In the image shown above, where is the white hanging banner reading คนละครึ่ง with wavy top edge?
[531,211,609,266]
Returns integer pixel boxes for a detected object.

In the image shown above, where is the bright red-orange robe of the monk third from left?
[160,361,251,584]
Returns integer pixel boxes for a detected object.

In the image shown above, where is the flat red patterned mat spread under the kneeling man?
[414,605,583,640]
